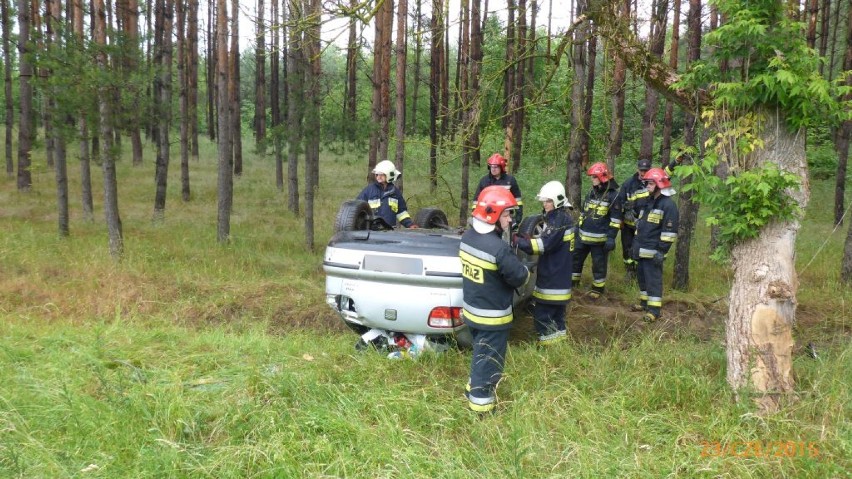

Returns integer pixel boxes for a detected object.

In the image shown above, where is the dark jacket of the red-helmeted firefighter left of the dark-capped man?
[579,179,622,244]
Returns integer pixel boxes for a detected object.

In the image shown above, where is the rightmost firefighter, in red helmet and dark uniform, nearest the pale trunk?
[631,168,678,322]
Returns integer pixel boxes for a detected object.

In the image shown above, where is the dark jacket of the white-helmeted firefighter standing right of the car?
[518,208,574,304]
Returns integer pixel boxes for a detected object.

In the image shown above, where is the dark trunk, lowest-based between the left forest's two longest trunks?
[153,0,174,222]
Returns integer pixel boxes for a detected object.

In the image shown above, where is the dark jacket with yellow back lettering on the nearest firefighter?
[459,228,524,330]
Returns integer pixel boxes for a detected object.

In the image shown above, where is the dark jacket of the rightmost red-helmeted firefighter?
[633,195,678,259]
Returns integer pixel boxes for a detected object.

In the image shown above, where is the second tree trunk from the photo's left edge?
[17,0,33,191]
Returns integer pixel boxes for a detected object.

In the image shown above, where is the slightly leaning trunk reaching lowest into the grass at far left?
[93,0,124,260]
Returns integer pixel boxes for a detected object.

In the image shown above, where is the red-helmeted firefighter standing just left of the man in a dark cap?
[571,163,622,299]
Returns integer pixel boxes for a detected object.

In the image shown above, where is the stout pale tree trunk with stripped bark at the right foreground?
[725,111,810,411]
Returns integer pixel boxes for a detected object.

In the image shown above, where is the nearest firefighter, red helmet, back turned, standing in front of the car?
[459,186,530,413]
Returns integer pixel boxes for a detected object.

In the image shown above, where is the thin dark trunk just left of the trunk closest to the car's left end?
[287,0,305,216]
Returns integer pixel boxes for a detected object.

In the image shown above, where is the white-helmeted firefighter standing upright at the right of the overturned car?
[513,181,574,346]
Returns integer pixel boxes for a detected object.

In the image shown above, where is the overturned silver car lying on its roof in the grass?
[323,200,541,347]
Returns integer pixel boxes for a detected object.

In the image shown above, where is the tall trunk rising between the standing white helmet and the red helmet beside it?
[565,0,589,205]
